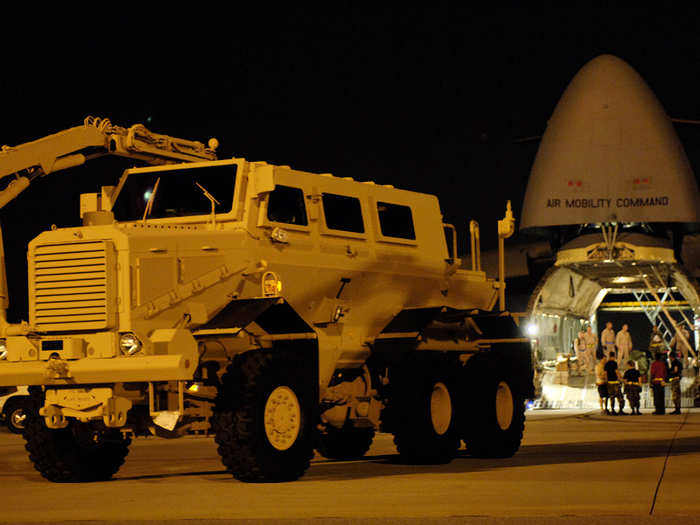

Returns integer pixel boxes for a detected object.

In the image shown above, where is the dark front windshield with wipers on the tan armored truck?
[112,164,236,221]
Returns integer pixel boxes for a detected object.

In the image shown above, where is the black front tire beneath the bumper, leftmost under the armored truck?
[23,386,131,483]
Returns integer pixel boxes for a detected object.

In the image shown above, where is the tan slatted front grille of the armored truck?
[29,241,113,331]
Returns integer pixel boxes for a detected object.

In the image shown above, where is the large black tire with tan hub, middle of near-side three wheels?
[389,355,460,464]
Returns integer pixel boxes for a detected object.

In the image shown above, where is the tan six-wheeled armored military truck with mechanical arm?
[0,119,532,481]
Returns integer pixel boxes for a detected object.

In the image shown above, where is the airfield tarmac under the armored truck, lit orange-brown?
[0,409,700,525]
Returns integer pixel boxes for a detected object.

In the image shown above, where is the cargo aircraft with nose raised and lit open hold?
[486,55,700,406]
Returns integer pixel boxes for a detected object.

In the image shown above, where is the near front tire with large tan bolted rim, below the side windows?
[213,350,315,482]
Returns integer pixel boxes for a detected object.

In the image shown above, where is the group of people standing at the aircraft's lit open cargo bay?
[574,322,690,415]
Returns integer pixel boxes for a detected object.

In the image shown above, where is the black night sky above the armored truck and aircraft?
[0,7,700,318]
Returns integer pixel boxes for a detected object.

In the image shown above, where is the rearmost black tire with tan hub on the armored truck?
[460,355,525,458]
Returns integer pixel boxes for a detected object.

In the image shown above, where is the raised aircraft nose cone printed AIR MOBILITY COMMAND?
[520,55,700,229]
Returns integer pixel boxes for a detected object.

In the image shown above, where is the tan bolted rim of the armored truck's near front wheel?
[265,386,301,450]
